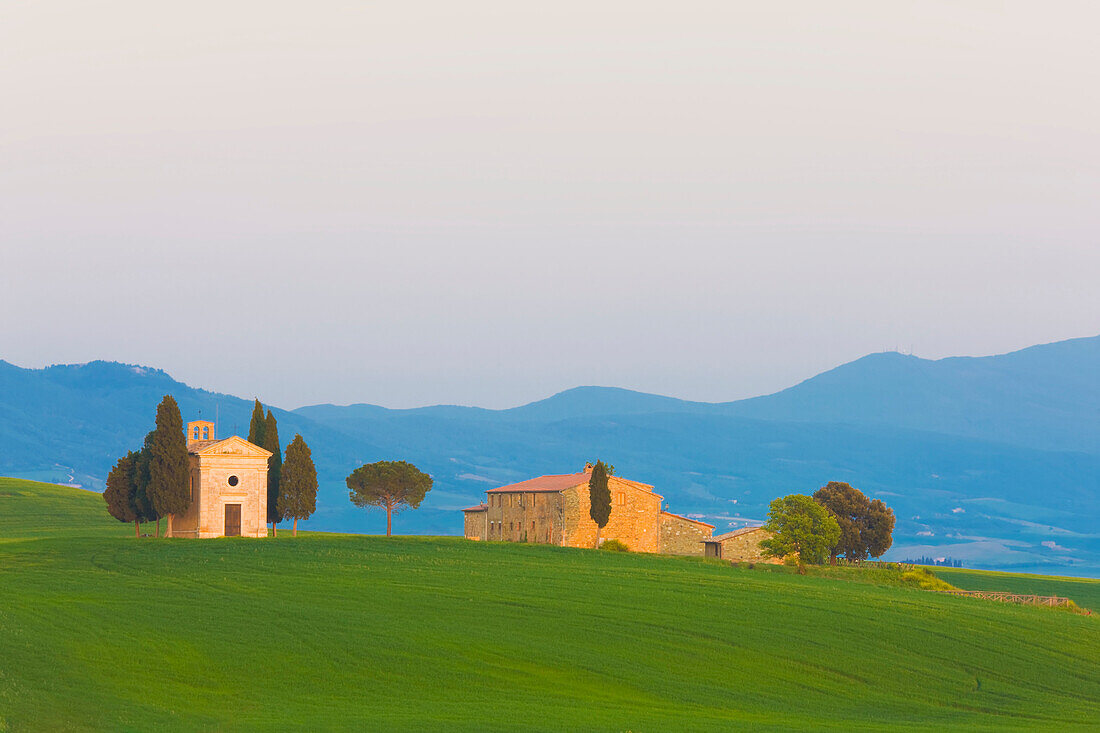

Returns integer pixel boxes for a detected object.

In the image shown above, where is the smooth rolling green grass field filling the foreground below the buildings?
[0,479,1100,731]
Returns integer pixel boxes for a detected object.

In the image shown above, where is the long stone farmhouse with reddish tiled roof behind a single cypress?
[463,464,714,555]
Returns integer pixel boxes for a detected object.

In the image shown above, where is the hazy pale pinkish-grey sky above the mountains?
[0,0,1100,407]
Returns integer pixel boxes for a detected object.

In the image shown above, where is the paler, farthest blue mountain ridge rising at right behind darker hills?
[723,336,1100,453]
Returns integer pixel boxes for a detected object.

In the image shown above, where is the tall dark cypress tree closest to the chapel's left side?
[149,395,191,537]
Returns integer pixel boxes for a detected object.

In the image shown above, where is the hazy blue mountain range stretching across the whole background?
[0,337,1100,575]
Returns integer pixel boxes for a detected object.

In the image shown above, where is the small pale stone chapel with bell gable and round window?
[172,420,272,537]
